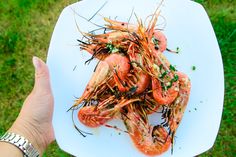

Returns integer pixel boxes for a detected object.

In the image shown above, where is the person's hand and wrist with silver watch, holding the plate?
[0,57,55,157]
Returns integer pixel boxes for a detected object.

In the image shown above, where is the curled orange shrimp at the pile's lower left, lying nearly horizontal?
[78,96,140,128]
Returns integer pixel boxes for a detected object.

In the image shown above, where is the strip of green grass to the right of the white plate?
[195,0,236,157]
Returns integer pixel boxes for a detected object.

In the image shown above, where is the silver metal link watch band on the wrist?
[0,132,39,157]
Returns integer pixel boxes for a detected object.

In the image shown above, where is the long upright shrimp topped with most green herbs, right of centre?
[126,14,179,105]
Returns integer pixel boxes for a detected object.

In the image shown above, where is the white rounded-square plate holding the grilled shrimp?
[47,0,224,157]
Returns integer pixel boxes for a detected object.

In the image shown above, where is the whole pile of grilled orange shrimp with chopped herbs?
[69,11,191,156]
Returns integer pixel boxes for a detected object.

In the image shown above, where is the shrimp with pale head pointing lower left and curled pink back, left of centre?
[71,53,130,108]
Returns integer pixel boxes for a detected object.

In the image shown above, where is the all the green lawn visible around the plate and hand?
[0,0,236,157]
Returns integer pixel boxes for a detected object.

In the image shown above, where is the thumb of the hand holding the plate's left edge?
[32,56,51,93]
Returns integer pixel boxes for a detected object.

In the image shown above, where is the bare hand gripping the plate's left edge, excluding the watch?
[9,57,54,155]
